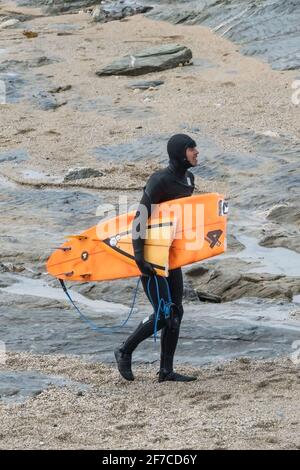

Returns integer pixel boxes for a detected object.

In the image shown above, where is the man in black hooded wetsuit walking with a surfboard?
[114,134,199,382]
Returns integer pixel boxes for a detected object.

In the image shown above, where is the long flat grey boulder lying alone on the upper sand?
[96,44,192,76]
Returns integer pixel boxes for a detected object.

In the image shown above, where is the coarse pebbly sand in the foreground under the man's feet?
[0,353,300,450]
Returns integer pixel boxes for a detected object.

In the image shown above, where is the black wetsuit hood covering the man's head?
[167,134,197,174]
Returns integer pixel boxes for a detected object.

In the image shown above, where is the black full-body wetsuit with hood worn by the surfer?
[122,134,196,372]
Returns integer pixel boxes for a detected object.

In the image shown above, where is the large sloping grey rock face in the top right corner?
[148,0,300,70]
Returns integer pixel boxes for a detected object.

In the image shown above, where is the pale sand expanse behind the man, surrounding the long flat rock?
[0,5,300,189]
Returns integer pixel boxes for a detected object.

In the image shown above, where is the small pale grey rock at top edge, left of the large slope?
[92,0,153,23]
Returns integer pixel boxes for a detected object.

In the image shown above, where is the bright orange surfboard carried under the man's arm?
[47,193,227,281]
